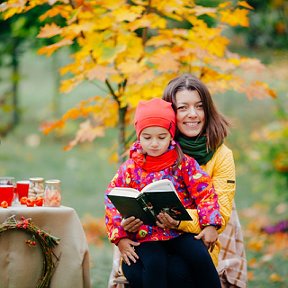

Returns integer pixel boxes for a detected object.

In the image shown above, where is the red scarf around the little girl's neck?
[130,141,178,172]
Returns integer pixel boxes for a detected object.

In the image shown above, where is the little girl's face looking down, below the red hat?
[139,126,172,157]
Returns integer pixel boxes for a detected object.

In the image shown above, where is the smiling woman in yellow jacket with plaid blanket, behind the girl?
[163,74,247,288]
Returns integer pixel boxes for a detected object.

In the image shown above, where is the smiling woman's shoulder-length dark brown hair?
[162,74,230,151]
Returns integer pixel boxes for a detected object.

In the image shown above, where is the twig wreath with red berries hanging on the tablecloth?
[0,215,60,288]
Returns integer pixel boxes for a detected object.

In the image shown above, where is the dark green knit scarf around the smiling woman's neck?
[176,133,215,165]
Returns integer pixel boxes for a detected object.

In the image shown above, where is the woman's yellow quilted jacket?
[178,144,236,267]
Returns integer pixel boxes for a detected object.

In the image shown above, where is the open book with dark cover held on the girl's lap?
[107,179,192,225]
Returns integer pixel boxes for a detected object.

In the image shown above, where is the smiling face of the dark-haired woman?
[175,90,205,137]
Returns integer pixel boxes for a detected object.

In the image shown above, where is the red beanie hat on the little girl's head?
[134,98,176,138]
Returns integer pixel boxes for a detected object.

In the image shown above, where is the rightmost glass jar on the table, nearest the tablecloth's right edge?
[44,179,61,207]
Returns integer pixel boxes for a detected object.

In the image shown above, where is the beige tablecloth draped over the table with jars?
[0,206,91,288]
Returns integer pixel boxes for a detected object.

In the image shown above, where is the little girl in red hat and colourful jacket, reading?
[105,99,222,288]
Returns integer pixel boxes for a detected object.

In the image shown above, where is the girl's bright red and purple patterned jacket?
[105,142,222,245]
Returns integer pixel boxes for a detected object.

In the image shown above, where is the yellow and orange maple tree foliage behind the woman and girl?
[1,0,275,160]
